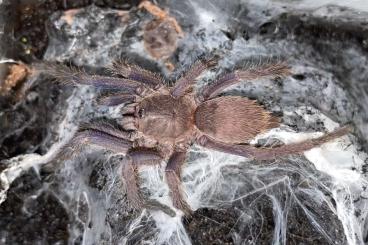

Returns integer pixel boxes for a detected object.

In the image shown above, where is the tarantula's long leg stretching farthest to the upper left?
[38,64,149,96]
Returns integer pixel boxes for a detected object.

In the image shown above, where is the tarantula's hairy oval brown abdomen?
[195,96,279,143]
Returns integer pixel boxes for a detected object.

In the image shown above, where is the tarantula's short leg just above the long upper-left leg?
[110,61,164,90]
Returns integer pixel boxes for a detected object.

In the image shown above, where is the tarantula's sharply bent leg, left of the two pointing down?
[122,149,162,209]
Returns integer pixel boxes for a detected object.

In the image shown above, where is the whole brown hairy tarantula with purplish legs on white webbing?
[41,58,350,213]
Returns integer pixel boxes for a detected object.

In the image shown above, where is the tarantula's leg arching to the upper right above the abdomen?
[198,62,291,101]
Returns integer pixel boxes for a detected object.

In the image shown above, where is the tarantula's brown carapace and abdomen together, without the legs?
[134,93,279,148]
